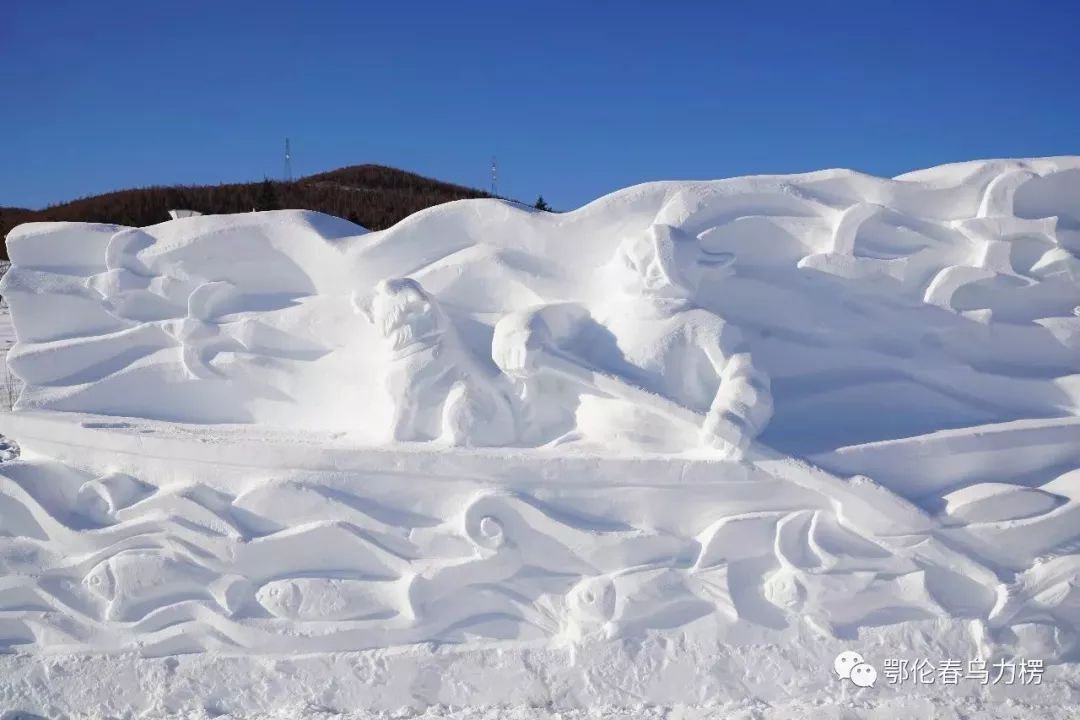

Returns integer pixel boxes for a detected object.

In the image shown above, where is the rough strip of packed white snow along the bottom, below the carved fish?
[0,649,1077,720]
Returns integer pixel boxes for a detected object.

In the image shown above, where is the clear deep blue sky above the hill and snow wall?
[0,0,1080,208]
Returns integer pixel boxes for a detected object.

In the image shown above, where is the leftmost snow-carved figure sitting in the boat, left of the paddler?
[356,277,515,445]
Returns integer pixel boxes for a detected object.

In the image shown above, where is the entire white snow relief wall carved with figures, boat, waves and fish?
[0,158,1080,720]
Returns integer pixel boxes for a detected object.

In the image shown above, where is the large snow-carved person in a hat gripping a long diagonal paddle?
[492,225,772,459]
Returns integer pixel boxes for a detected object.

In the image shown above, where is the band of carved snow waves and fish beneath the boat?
[0,453,1080,660]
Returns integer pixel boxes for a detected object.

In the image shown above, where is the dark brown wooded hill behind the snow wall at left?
[0,165,490,258]
